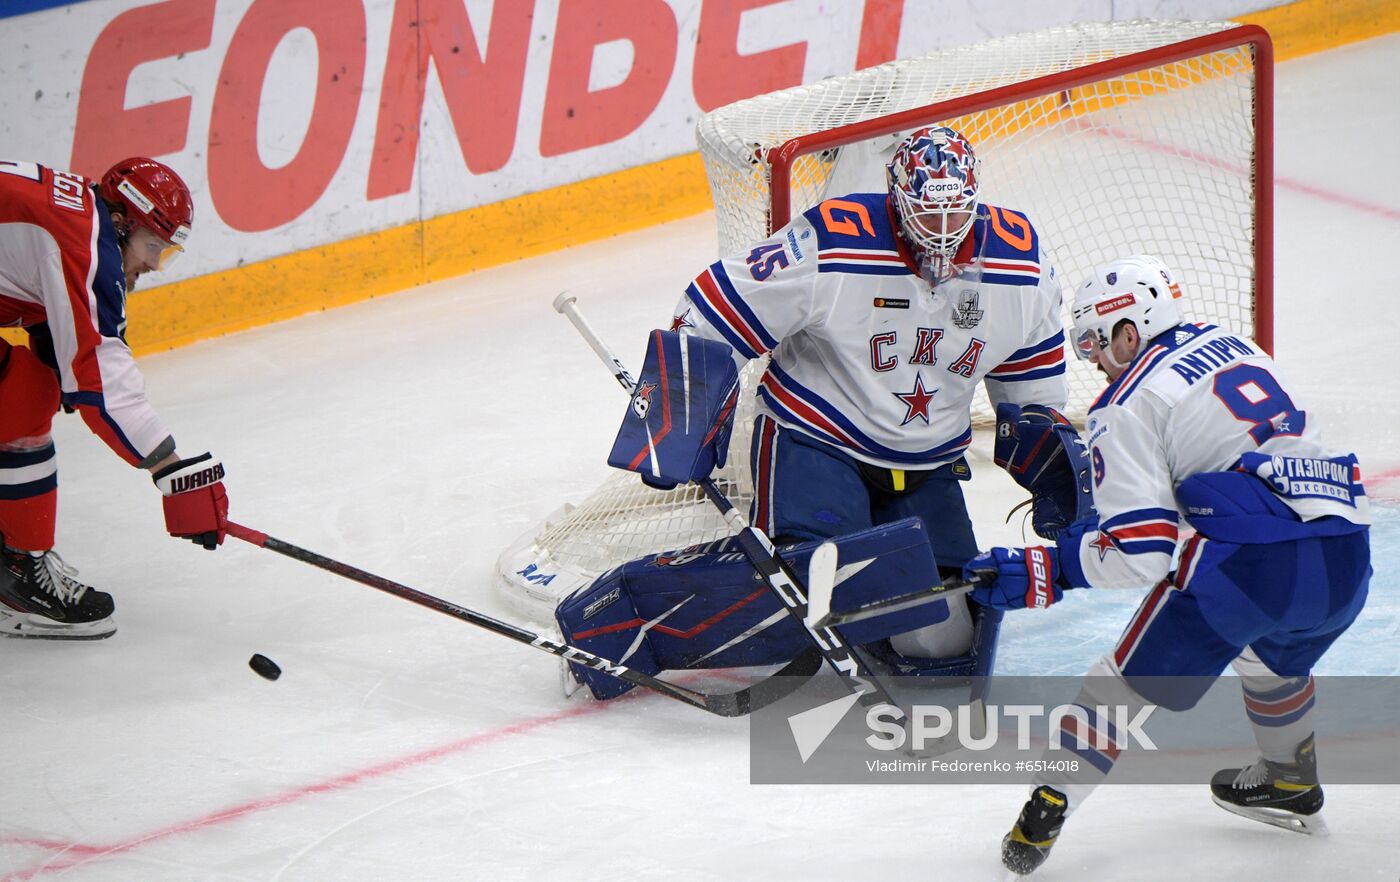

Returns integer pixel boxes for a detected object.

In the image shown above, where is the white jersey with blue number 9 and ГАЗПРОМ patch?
[1061,325,1369,588]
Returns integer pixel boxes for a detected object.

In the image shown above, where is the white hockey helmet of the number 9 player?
[1071,255,1182,358]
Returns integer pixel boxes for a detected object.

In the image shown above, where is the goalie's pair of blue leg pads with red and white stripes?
[556,518,946,699]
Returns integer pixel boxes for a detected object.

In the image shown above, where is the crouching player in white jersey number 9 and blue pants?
[966,256,1371,874]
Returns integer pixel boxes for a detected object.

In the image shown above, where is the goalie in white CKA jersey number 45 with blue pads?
[556,126,1086,705]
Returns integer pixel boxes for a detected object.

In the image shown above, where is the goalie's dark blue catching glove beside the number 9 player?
[993,405,1095,539]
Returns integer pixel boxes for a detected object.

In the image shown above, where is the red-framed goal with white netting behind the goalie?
[497,21,1273,616]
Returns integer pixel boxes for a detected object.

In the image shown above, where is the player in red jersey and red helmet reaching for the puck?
[0,158,228,640]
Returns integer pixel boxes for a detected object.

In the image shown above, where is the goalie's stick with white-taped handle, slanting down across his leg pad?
[554,291,899,707]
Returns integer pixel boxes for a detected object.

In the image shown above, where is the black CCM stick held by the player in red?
[227,521,822,717]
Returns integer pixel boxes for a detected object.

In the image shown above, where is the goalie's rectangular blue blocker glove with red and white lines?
[608,330,739,490]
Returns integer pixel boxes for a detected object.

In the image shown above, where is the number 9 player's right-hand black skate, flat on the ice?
[1211,735,1327,833]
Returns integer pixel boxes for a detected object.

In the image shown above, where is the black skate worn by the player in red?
[0,546,116,640]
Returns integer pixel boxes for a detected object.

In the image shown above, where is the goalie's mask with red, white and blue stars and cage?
[886,126,977,284]
